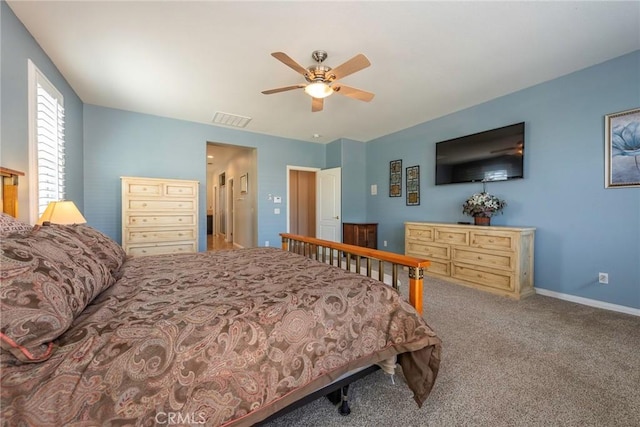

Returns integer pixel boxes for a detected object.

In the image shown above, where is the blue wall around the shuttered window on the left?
[0,1,84,221]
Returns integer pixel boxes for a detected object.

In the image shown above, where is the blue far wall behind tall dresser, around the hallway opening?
[84,105,325,250]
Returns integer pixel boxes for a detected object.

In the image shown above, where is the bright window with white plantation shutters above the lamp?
[28,61,65,223]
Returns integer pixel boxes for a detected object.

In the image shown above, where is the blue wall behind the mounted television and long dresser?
[366,51,640,308]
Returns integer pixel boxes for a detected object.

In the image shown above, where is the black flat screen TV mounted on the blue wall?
[436,122,524,185]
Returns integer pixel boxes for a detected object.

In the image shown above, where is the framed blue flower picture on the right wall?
[604,108,640,188]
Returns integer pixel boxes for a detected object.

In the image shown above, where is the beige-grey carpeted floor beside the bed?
[260,278,640,427]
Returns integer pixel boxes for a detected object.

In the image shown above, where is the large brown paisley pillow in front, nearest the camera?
[0,226,115,362]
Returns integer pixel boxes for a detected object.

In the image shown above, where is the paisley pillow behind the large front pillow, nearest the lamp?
[51,224,127,275]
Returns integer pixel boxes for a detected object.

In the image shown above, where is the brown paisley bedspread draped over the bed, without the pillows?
[0,248,440,426]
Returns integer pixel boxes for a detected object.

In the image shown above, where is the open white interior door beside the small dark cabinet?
[316,168,342,242]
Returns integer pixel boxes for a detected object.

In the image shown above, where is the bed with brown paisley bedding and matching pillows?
[0,217,441,426]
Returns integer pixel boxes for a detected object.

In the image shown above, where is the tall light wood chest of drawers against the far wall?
[122,177,198,256]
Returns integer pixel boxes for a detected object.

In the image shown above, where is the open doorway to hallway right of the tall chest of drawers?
[206,142,257,250]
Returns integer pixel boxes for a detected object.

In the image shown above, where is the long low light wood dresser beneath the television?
[405,222,535,299]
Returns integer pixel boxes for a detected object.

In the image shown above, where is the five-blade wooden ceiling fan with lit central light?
[262,50,375,113]
